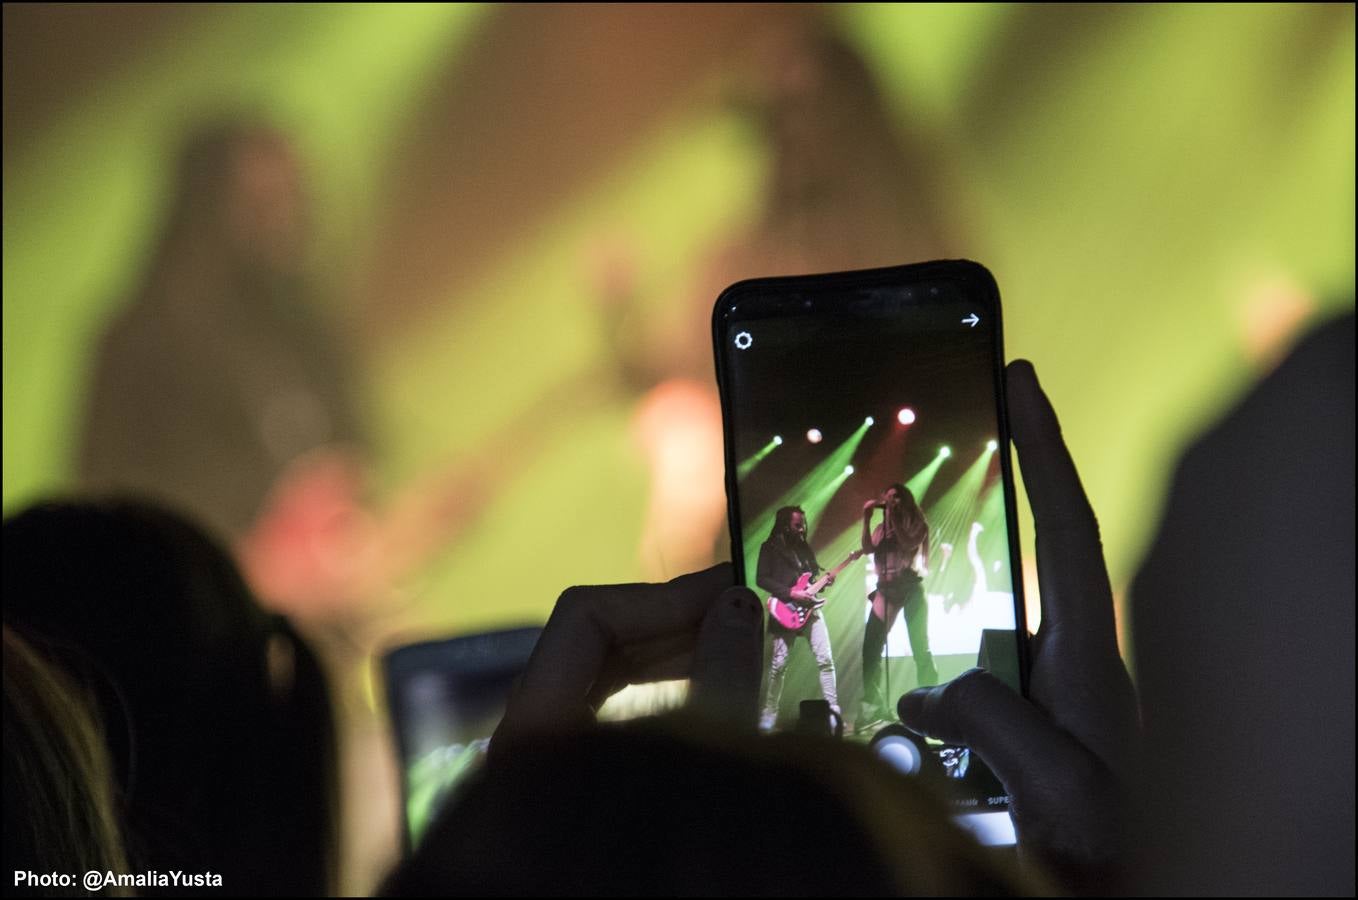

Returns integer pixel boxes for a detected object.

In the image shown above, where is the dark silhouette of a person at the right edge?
[1133,314,1355,895]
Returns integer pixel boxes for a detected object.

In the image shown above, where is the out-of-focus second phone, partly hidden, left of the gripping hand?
[382,626,542,852]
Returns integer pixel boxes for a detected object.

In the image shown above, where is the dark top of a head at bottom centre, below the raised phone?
[383,719,1027,897]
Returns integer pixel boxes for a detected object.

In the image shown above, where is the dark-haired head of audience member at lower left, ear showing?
[3,502,337,896]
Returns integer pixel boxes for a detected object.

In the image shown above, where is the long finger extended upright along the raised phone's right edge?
[1005,360,1116,649]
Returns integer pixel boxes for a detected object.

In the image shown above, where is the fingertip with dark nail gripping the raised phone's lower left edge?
[689,586,763,730]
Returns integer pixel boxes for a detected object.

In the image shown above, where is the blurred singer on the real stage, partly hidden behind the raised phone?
[596,24,956,577]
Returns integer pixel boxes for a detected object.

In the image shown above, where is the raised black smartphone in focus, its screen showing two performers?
[713,261,1028,844]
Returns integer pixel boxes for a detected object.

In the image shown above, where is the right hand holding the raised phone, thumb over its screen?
[899,361,1139,893]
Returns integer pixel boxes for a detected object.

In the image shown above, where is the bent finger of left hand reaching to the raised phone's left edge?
[497,563,735,734]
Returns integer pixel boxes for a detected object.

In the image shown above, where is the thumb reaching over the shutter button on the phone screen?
[896,669,1088,797]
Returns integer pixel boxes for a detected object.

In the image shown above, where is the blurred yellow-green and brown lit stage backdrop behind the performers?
[4,4,1354,630]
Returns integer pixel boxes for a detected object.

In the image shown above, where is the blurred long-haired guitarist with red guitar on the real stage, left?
[68,118,589,890]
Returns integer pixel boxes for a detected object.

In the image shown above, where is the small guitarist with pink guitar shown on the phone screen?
[756,506,839,732]
